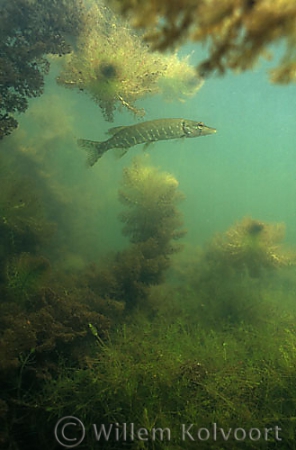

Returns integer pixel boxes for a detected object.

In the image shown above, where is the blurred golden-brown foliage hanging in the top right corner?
[113,0,296,83]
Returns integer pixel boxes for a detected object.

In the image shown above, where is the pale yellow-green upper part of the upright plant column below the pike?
[119,158,185,250]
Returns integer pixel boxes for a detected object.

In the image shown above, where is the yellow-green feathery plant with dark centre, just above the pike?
[57,1,202,121]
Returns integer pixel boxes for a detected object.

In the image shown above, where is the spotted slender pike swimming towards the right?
[77,119,217,166]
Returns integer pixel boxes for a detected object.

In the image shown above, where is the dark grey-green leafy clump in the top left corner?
[0,0,84,139]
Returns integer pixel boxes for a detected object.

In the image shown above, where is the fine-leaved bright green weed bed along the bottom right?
[40,302,295,450]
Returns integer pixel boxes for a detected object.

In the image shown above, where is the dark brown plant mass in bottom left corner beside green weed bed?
[0,279,110,449]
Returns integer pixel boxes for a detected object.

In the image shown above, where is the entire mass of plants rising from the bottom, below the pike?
[0,133,296,450]
